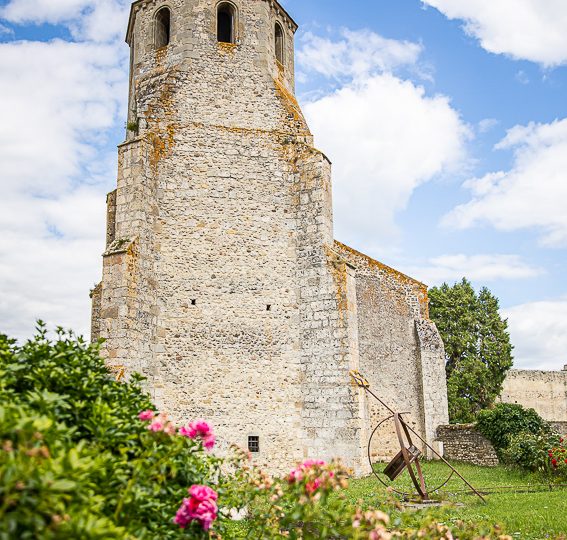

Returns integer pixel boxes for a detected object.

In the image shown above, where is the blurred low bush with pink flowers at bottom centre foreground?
[237,460,511,540]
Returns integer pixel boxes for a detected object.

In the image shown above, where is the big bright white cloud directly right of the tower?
[304,53,470,248]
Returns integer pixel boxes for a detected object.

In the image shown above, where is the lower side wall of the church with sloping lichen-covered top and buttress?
[335,242,448,459]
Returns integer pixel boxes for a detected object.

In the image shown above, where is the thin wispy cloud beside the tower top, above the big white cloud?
[297,29,422,79]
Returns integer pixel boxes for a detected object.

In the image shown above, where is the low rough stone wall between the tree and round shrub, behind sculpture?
[437,424,498,467]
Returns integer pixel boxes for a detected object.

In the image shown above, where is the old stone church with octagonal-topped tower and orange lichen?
[92,0,448,472]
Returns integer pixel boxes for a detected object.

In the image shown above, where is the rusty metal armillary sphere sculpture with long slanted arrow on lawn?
[350,371,486,503]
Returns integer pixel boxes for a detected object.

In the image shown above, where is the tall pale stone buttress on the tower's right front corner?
[296,148,367,473]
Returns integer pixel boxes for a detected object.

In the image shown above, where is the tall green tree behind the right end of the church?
[429,278,513,423]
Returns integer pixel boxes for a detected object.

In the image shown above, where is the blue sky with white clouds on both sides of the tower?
[0,0,567,369]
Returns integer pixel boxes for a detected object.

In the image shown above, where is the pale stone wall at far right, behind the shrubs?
[500,369,567,422]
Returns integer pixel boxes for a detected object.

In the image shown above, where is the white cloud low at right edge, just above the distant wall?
[502,298,567,370]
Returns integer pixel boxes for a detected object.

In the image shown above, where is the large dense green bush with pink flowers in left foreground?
[0,326,246,540]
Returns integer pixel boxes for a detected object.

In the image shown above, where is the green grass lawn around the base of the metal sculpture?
[347,462,567,540]
